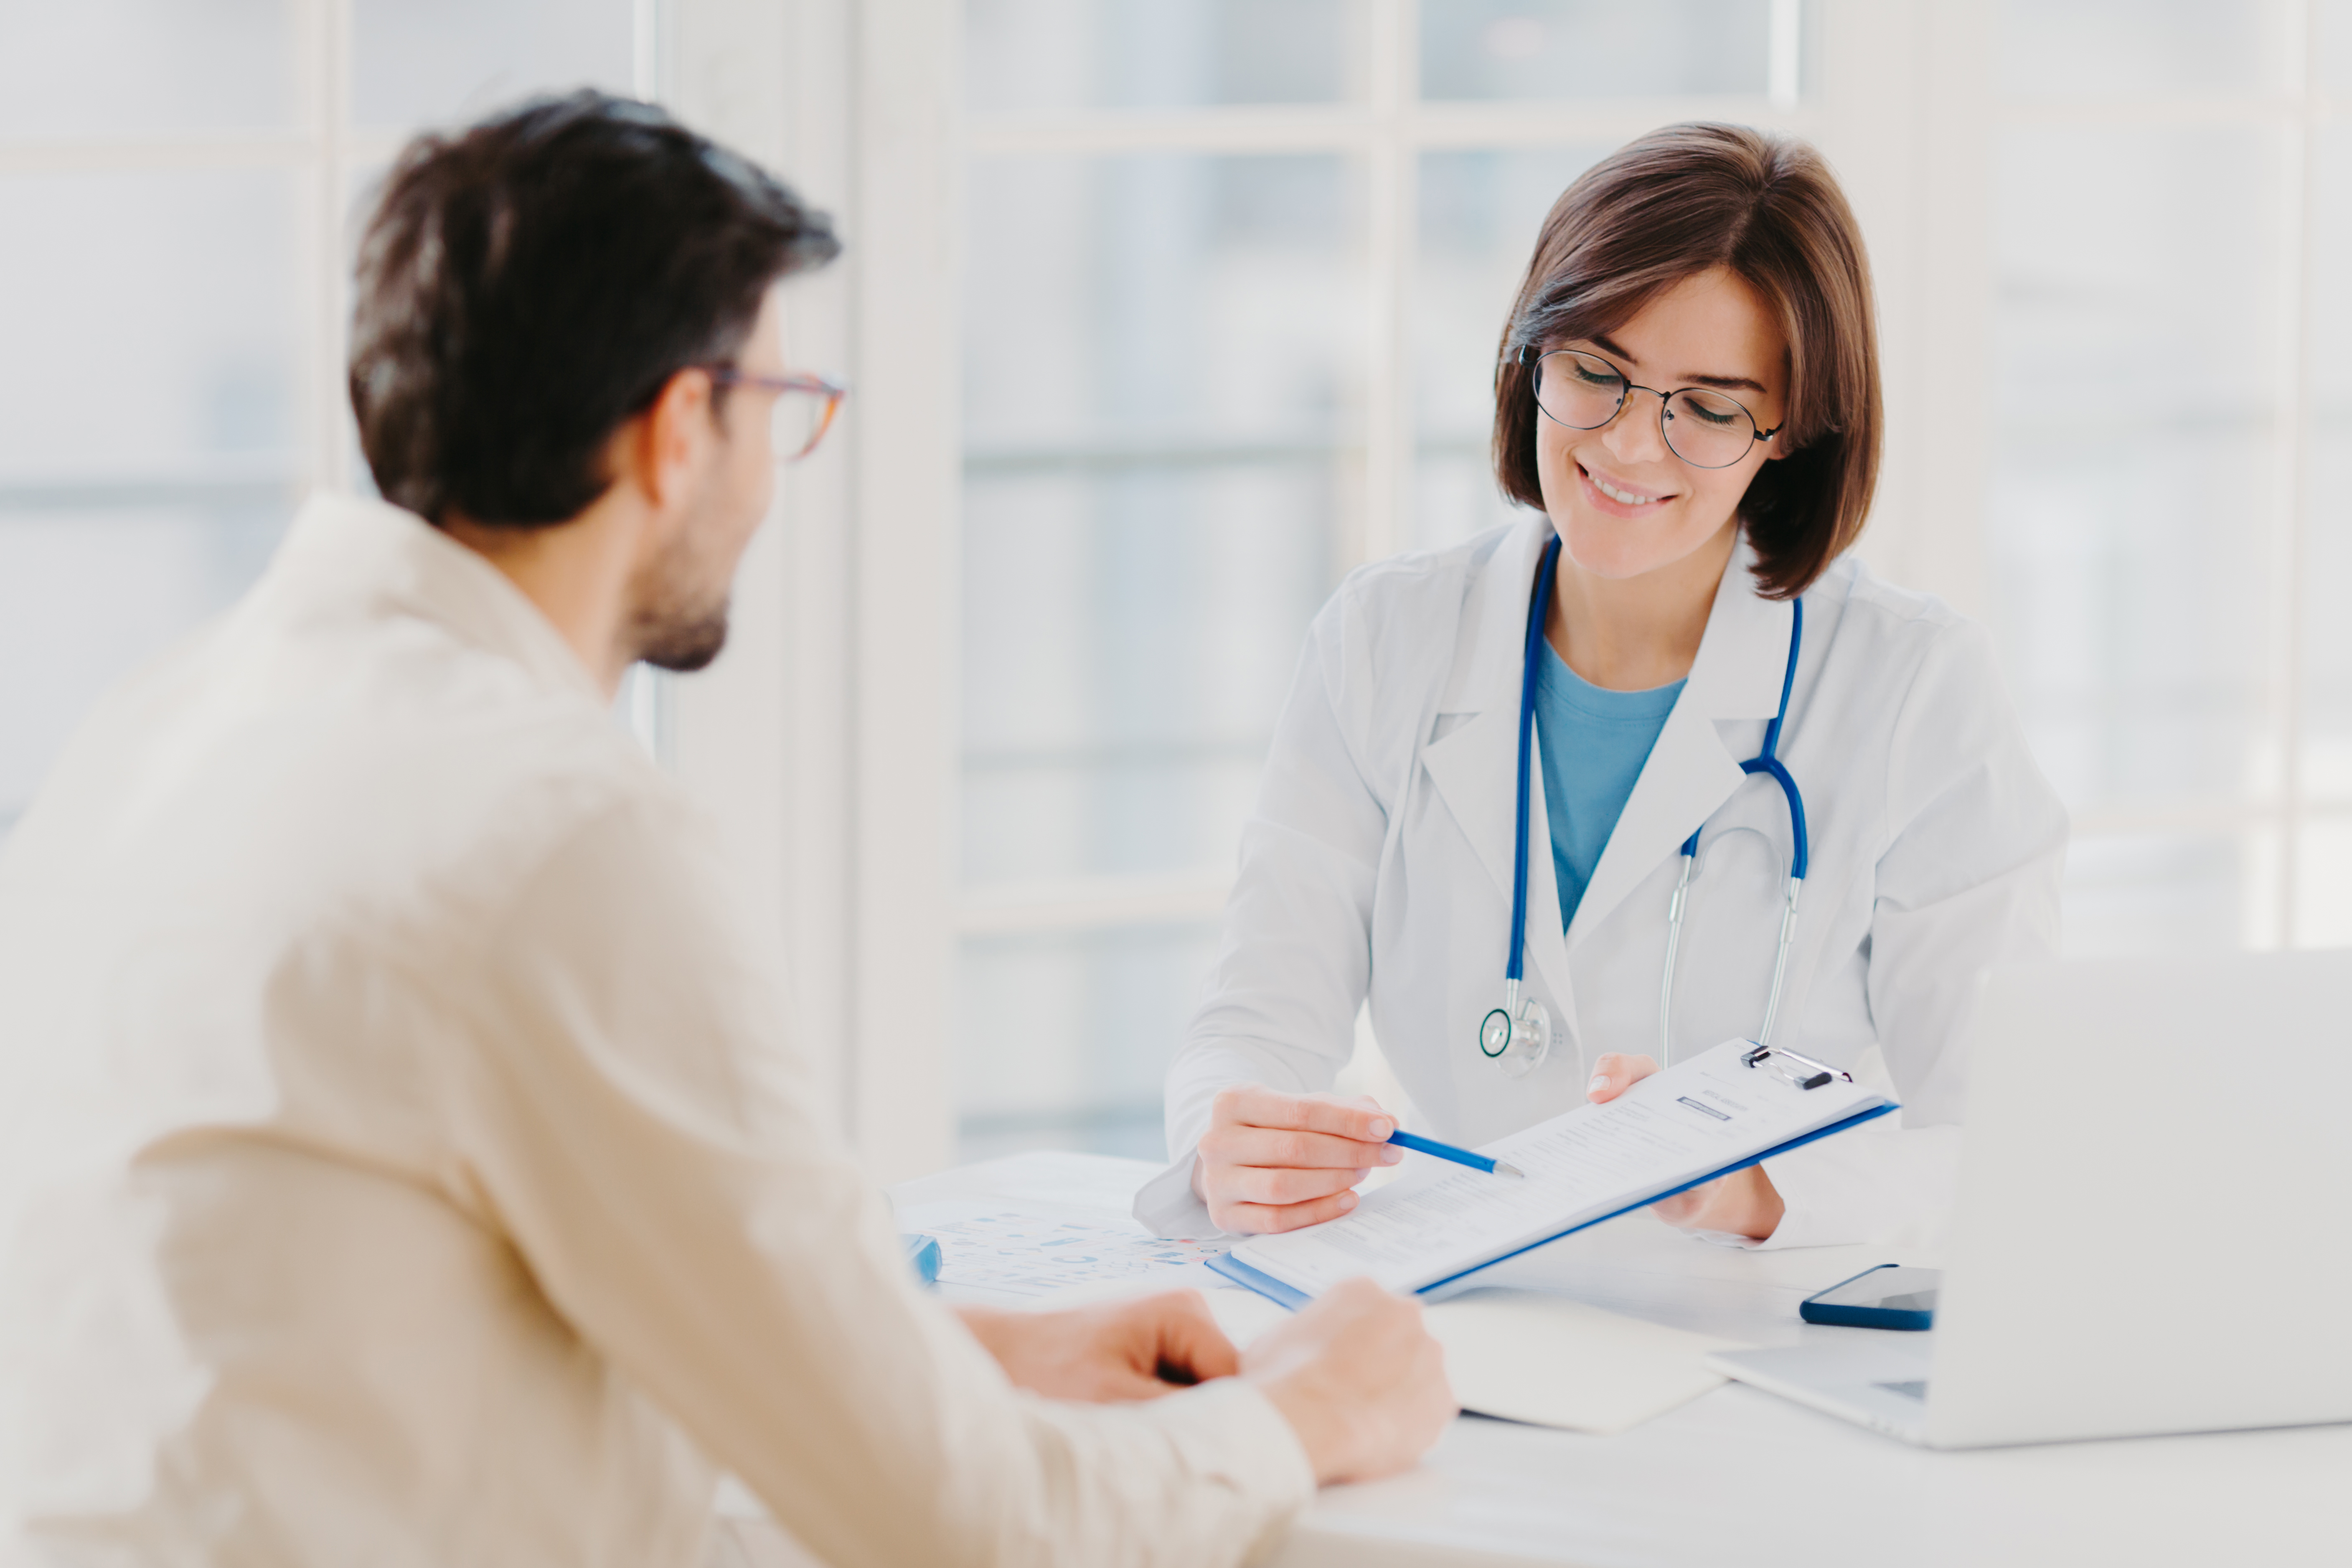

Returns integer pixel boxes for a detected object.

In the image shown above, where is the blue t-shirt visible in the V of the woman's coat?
[1536,639,1681,931]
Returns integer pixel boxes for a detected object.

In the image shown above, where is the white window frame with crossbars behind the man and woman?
[18,0,2352,1180]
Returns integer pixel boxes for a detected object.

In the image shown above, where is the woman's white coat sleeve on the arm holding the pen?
[1134,588,1411,1237]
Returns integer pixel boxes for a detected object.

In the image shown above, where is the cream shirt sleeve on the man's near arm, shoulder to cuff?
[432,799,1313,1568]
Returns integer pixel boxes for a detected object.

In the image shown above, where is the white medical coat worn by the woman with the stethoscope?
[1136,515,2068,1246]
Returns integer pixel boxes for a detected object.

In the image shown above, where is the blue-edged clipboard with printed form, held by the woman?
[1209,1039,1896,1307]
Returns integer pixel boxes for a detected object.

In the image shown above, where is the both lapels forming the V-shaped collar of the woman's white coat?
[1423,513,1792,1009]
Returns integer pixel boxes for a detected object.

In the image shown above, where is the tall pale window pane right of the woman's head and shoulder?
[1985,127,2281,811]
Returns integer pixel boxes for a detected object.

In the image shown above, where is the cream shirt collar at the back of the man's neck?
[264,491,607,708]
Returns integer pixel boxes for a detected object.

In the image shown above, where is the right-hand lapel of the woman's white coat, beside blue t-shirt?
[1567,536,1795,948]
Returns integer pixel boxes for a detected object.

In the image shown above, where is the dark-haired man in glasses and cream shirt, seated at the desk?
[0,94,1451,1568]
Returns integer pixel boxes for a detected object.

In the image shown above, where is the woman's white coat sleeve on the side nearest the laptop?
[1764,623,2068,1246]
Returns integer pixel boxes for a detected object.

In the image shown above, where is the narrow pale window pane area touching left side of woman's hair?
[1407,146,1606,548]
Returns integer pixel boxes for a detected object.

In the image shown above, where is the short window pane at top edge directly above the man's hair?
[351,0,638,129]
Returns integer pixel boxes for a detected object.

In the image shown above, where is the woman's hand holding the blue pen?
[1192,1084,1404,1234]
